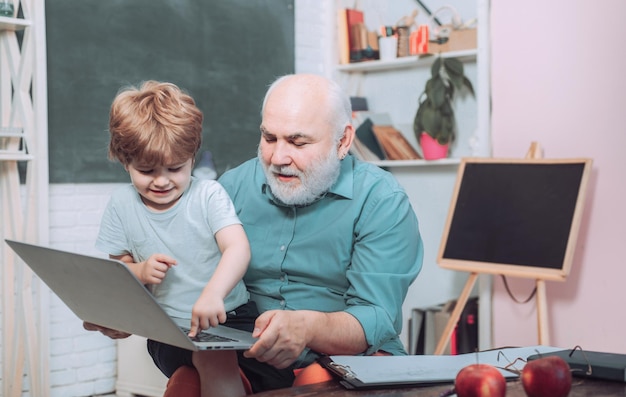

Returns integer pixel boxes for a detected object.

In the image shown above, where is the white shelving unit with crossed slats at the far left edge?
[0,0,50,397]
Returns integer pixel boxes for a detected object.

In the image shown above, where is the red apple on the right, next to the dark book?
[522,356,572,397]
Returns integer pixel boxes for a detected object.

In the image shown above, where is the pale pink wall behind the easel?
[491,0,626,353]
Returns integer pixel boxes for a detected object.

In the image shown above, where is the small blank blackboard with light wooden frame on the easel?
[438,158,592,281]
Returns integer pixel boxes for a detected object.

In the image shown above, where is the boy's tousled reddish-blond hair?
[109,80,203,166]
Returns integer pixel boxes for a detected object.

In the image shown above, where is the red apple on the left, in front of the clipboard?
[454,364,506,397]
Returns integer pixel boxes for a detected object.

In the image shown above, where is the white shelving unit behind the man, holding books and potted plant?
[334,0,491,348]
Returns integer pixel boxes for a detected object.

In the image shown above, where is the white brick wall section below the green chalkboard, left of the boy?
[50,184,120,397]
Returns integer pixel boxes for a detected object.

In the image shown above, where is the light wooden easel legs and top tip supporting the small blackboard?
[435,142,550,355]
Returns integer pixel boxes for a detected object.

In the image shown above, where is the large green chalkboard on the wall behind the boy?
[46,0,294,183]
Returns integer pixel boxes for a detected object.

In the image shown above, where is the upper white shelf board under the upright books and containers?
[337,50,477,73]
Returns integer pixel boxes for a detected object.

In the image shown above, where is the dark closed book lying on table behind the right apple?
[528,349,626,382]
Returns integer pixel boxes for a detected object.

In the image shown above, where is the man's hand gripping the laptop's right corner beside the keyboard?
[244,310,311,369]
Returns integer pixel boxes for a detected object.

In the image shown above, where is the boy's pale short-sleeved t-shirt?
[96,177,249,319]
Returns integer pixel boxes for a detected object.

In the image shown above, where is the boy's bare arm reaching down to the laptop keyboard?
[189,224,250,337]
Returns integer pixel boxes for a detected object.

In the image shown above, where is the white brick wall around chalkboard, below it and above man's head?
[36,0,335,397]
